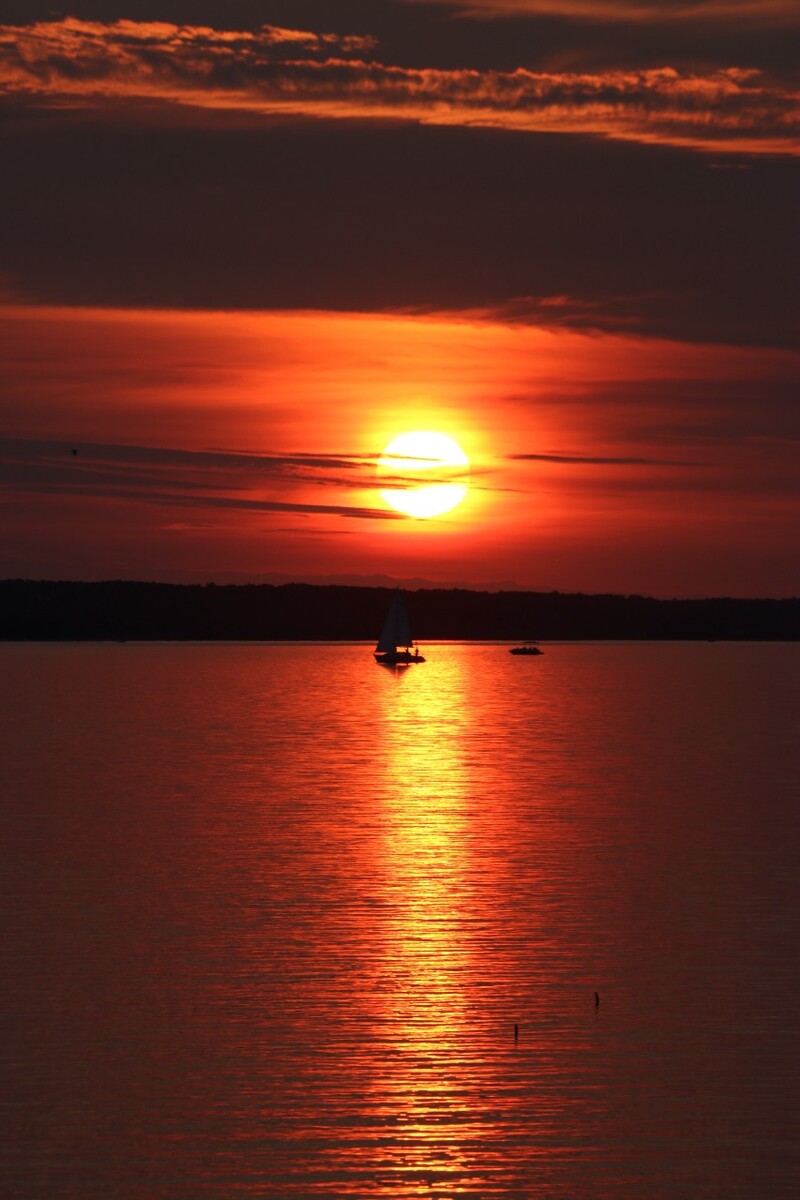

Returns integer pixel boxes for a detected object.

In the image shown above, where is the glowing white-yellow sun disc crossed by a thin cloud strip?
[378,430,469,517]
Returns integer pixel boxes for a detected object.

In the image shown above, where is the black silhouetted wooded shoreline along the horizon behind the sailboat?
[0,580,800,641]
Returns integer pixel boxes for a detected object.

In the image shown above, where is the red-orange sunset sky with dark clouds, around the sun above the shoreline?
[0,0,800,596]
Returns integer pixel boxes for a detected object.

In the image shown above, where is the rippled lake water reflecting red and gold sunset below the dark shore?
[0,643,800,1200]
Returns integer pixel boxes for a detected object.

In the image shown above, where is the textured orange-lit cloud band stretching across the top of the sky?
[0,19,800,154]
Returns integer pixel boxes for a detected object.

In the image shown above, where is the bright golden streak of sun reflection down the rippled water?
[357,656,510,1186]
